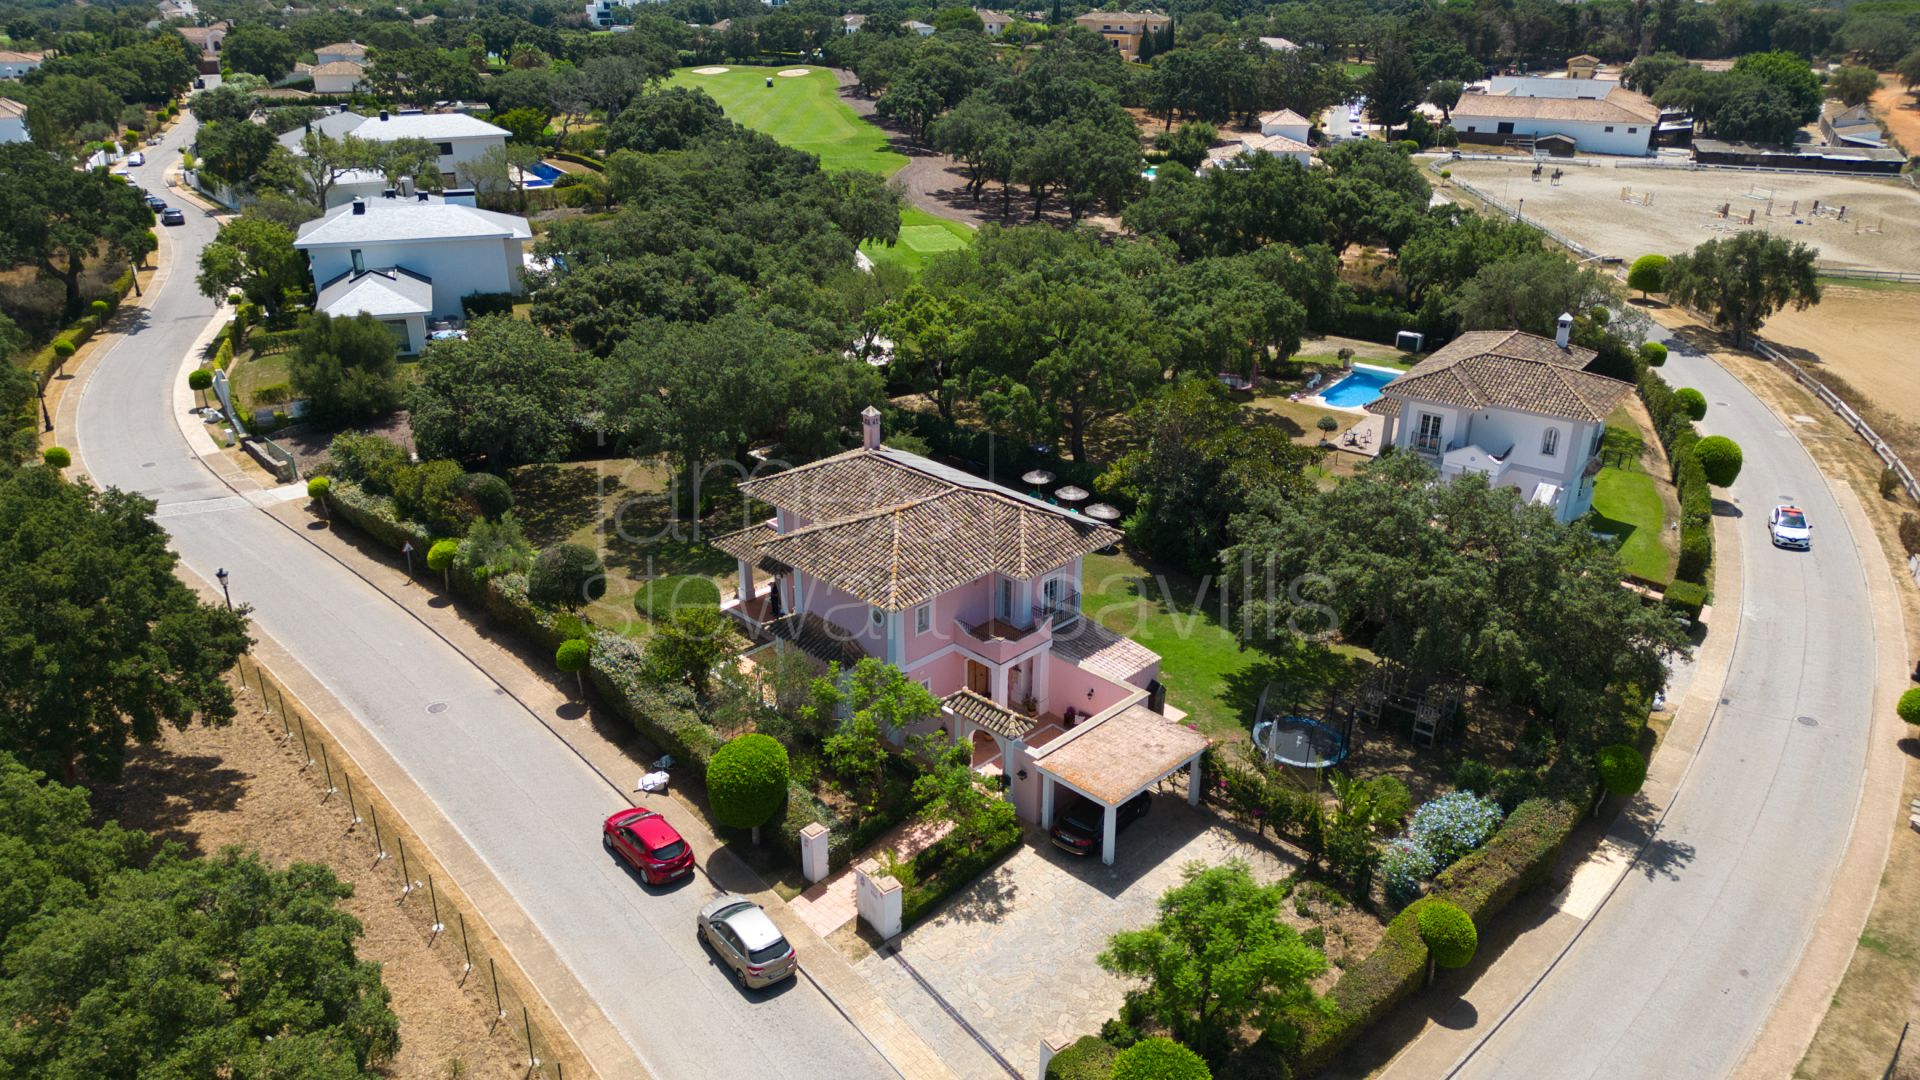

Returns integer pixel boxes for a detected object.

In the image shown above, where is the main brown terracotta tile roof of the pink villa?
[733,448,1119,611]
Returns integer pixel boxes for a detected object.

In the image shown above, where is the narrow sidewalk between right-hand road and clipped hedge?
[1380,495,1743,1080]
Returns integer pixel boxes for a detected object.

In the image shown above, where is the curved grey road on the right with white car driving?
[1455,338,1874,1080]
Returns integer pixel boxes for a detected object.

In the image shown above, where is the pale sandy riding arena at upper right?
[1448,160,1920,271]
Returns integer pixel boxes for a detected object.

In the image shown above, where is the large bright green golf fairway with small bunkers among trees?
[668,67,906,177]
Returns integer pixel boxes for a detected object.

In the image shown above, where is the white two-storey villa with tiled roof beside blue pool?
[1367,315,1632,521]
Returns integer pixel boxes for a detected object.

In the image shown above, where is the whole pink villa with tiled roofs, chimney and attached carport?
[712,407,1206,863]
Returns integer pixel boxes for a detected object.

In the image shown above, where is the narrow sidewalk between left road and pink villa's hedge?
[267,500,952,1080]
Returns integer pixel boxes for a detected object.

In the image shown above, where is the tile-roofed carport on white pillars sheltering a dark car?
[1035,703,1208,867]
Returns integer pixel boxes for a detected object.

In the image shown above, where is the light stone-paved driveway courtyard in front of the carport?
[858,794,1294,1080]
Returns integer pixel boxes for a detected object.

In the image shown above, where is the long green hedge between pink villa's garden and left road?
[326,477,910,869]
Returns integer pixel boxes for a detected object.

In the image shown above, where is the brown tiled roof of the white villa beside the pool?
[1371,331,1632,421]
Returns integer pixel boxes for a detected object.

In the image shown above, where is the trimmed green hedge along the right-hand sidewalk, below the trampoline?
[1286,799,1580,1074]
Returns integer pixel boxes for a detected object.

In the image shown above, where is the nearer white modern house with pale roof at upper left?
[294,196,534,354]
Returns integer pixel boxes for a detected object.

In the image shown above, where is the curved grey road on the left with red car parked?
[79,117,893,1080]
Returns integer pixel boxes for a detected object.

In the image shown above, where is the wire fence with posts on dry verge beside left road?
[234,655,576,1080]
